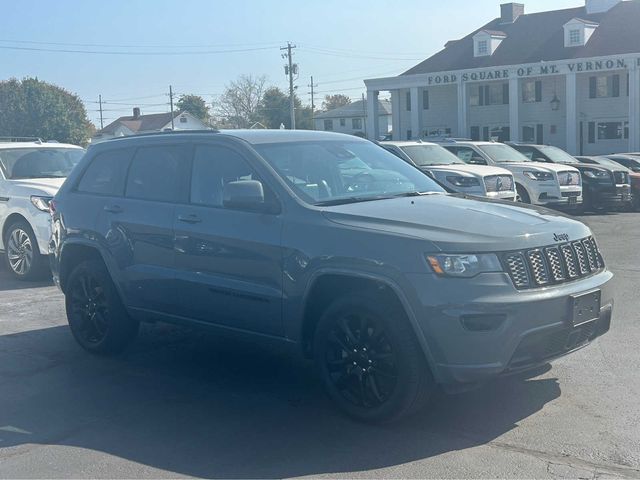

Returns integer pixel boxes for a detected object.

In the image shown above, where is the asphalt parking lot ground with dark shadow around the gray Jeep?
[0,213,640,478]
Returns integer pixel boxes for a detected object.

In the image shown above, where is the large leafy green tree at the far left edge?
[0,78,95,145]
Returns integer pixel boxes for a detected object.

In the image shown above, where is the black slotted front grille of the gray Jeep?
[502,237,604,289]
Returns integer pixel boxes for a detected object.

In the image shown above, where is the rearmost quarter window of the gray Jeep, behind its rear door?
[78,148,133,195]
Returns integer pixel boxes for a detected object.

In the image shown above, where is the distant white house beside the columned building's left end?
[314,100,391,139]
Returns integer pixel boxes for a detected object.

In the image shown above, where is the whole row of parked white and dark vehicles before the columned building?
[380,139,640,212]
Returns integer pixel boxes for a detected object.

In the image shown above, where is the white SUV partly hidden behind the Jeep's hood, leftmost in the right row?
[380,141,516,200]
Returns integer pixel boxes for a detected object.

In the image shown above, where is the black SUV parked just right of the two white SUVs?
[509,143,632,211]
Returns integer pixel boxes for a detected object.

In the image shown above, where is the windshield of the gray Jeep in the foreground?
[254,140,445,205]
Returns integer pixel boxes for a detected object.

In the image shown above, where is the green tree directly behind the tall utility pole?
[258,87,313,130]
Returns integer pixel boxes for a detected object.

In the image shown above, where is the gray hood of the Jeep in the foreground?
[323,194,591,253]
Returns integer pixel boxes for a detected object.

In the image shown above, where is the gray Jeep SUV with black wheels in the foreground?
[50,130,613,421]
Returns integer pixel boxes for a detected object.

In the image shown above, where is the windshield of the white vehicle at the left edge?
[0,148,84,180]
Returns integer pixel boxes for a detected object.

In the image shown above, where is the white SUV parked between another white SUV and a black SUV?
[442,140,582,209]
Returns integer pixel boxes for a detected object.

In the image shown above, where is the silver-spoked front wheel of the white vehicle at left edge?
[3,220,48,281]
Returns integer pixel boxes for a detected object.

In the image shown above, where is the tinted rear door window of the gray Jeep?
[126,145,189,202]
